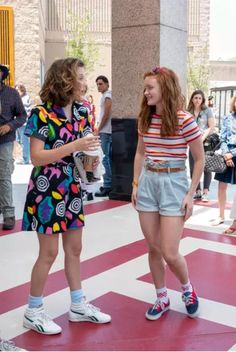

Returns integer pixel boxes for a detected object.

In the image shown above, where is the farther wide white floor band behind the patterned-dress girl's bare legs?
[0,205,143,291]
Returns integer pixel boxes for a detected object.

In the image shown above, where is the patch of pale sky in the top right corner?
[210,0,236,60]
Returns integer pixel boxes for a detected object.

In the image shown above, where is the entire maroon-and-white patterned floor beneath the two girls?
[0,166,236,351]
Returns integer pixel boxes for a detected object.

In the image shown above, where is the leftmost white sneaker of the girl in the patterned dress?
[23,307,61,335]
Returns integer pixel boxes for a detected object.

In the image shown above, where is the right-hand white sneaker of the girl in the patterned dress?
[69,298,111,324]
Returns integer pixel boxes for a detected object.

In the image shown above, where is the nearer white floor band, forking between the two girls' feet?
[3,246,236,339]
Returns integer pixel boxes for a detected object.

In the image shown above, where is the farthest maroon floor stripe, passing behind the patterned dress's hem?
[0,199,129,237]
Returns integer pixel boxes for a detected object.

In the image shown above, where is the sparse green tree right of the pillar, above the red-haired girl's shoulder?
[187,47,209,97]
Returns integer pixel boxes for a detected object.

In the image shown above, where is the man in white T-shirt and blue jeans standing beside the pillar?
[95,76,112,197]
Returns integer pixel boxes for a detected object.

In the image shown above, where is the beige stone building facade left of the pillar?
[0,0,111,106]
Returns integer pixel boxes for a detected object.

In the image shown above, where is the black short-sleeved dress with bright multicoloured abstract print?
[22,103,92,234]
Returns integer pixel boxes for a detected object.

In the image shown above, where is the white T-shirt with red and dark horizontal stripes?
[138,111,201,161]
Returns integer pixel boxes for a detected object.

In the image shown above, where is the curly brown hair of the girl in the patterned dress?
[39,58,84,107]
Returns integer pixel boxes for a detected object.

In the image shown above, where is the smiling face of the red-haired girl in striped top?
[144,76,162,112]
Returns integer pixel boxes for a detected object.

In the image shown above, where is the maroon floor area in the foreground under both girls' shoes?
[14,292,236,351]
